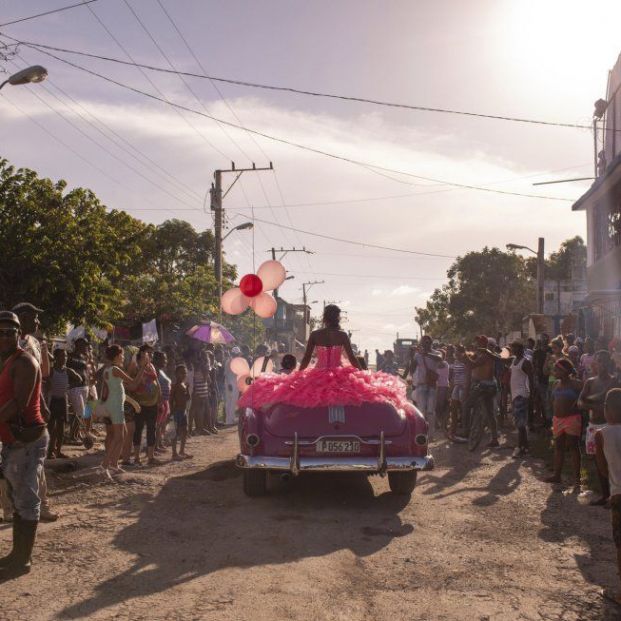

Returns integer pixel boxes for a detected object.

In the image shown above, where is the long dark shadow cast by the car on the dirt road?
[58,461,414,619]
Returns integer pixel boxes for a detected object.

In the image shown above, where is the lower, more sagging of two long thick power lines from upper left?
[4,35,575,203]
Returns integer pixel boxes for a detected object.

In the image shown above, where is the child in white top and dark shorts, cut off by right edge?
[595,388,621,605]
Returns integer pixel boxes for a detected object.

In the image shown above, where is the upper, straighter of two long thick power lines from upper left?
[6,35,593,130]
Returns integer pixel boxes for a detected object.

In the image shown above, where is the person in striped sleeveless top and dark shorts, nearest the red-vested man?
[47,348,82,459]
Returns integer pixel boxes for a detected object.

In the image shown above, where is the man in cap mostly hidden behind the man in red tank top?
[12,302,58,522]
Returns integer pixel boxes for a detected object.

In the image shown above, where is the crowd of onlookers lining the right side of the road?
[376,334,621,604]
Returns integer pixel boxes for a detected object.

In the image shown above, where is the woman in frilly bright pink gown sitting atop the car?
[239,304,414,410]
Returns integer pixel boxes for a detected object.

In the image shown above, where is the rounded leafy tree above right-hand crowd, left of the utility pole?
[416,248,535,339]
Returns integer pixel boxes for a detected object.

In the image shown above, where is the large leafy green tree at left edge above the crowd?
[0,159,148,330]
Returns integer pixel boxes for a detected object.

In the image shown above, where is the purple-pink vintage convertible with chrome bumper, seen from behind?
[237,402,433,496]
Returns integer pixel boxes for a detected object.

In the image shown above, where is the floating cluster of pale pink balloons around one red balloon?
[221,261,287,319]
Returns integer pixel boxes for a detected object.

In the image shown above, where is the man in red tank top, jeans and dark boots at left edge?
[0,311,49,581]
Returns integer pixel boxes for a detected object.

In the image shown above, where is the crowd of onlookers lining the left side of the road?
[0,303,288,581]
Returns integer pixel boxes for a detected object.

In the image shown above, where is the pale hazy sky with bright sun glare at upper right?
[0,0,621,349]
